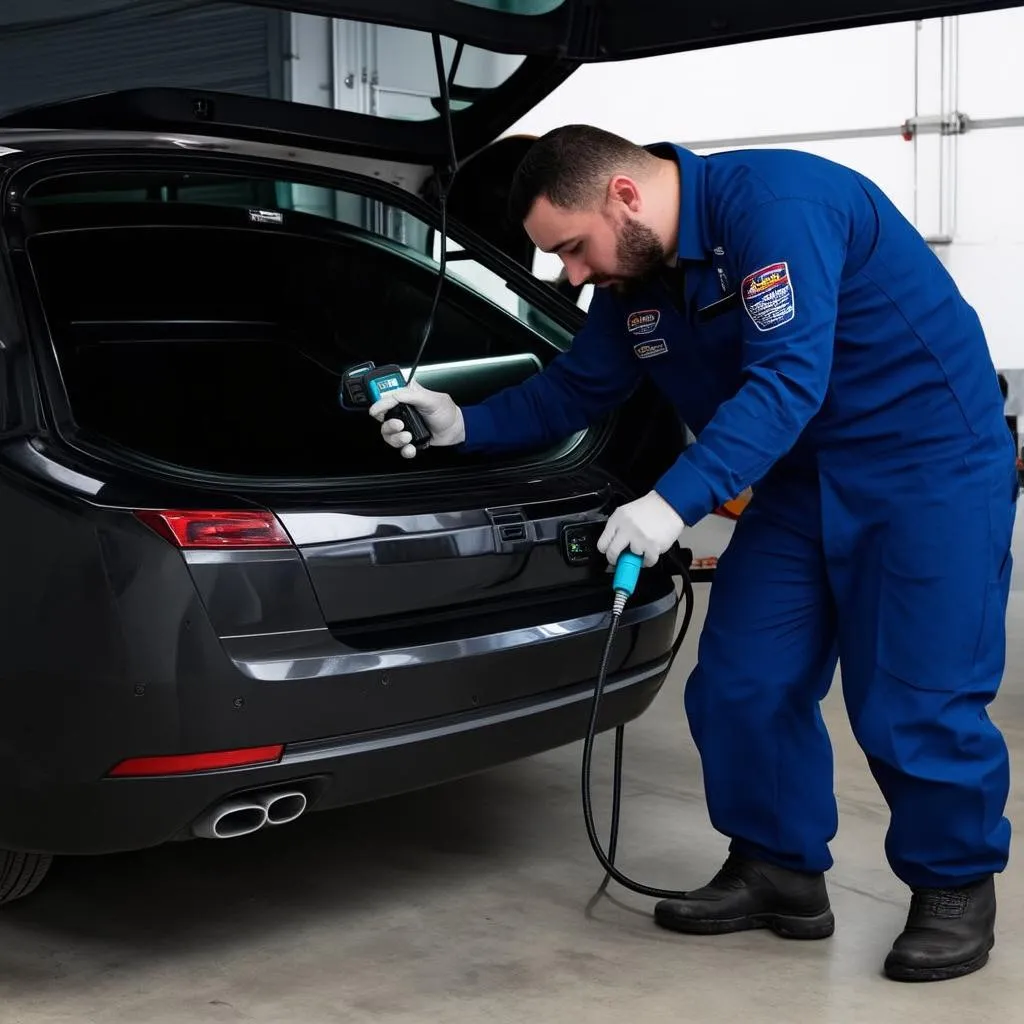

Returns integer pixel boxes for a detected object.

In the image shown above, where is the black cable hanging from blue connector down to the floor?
[581,552,694,899]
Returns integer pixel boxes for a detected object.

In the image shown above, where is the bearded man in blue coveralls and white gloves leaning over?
[371,126,1018,981]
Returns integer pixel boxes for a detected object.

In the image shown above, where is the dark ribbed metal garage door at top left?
[0,0,284,112]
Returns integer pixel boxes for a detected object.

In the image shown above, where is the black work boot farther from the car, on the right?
[885,877,995,981]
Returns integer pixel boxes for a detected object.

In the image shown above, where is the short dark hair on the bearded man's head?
[508,125,654,224]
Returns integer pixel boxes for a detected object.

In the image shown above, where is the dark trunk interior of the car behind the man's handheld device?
[27,192,581,479]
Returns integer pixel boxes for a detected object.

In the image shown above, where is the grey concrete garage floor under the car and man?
[0,546,1024,1024]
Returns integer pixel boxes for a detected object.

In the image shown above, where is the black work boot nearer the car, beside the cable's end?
[654,854,836,939]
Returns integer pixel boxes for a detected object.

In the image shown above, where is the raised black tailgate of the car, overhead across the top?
[0,0,1024,166]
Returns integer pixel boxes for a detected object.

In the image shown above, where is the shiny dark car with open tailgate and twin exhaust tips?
[0,0,1008,901]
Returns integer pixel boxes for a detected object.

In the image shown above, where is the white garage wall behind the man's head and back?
[501,8,1024,369]
